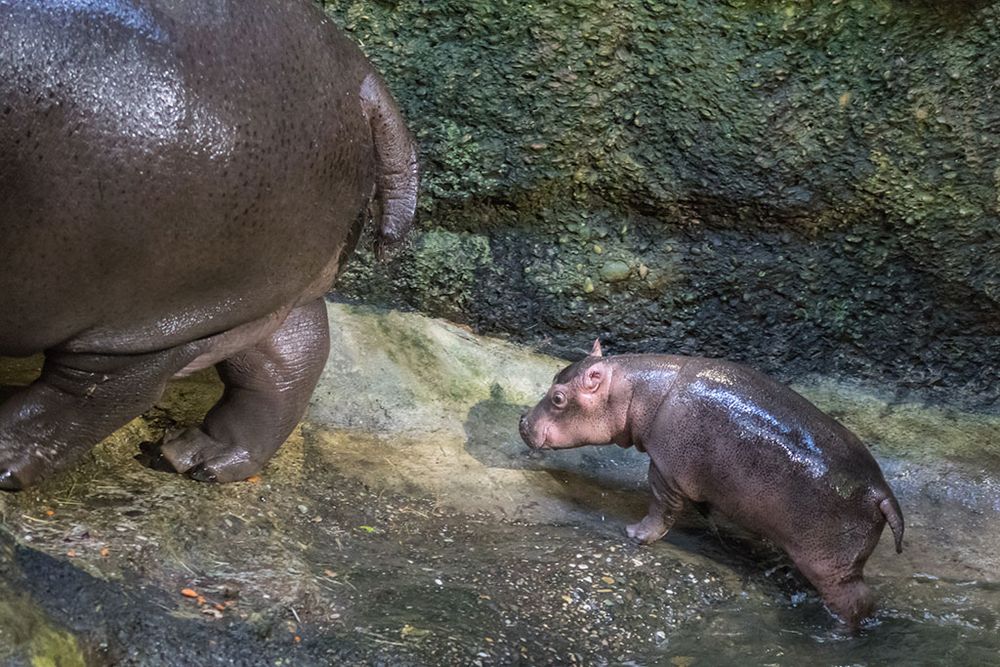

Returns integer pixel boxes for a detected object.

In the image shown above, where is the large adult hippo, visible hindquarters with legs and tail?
[0,0,417,490]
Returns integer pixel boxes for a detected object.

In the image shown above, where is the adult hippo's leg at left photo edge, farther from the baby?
[0,345,198,491]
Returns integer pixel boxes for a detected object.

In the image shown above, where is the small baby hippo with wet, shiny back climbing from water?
[521,341,903,630]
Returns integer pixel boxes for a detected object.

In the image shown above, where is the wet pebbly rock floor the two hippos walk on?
[0,305,1000,666]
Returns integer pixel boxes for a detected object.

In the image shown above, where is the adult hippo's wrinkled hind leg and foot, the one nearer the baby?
[139,299,330,482]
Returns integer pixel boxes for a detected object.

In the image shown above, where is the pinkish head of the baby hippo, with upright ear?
[521,341,620,449]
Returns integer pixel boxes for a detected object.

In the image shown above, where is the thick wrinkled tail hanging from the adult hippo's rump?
[361,73,420,257]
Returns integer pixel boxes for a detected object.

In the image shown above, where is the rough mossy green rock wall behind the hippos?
[324,0,1000,405]
